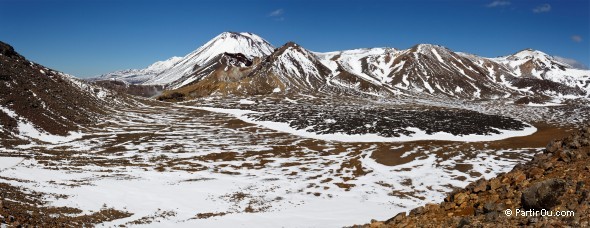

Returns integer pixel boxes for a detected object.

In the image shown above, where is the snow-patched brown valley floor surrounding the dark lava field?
[0,97,590,227]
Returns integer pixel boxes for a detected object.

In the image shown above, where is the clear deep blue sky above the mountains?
[0,0,590,77]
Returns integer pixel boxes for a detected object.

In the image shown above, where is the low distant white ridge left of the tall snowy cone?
[95,56,182,84]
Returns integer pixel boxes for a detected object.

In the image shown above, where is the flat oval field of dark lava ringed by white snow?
[249,105,528,137]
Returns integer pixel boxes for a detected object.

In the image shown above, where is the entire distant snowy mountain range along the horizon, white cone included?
[93,32,590,99]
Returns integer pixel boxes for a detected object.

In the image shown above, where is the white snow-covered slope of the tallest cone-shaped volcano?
[144,32,274,85]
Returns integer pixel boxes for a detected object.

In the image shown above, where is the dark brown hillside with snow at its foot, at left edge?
[0,42,114,145]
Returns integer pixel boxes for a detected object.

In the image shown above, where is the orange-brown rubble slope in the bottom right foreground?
[354,127,590,227]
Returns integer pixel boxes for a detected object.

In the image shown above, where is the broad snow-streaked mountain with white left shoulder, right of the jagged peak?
[323,44,520,98]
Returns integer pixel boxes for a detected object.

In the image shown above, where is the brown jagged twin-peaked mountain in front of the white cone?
[160,42,330,100]
